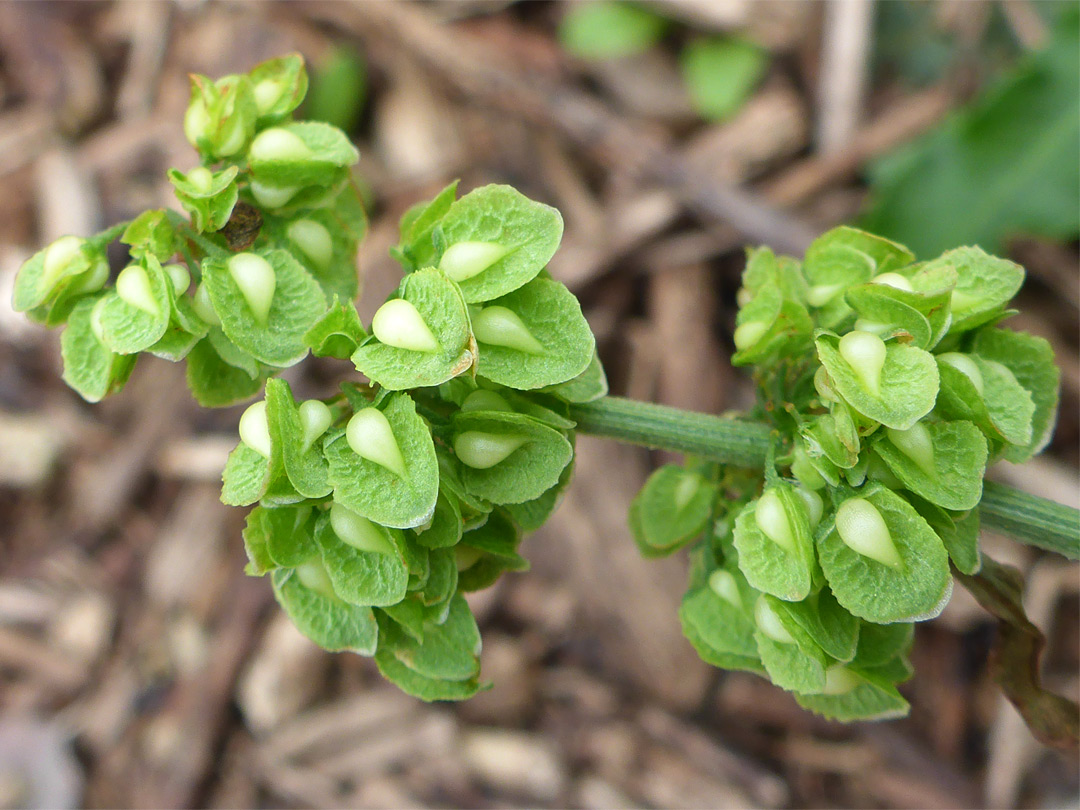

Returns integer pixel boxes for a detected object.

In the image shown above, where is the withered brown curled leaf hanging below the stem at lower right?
[959,558,1080,748]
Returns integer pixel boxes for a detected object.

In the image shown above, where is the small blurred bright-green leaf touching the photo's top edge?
[558,0,667,60]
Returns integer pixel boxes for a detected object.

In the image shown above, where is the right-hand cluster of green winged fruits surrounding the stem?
[631,227,1058,720]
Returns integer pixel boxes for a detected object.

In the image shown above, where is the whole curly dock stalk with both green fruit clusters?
[14,55,1078,737]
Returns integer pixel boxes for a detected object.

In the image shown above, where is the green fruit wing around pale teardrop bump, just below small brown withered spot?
[202,251,326,368]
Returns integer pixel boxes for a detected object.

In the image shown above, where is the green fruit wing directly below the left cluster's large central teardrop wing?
[315,512,408,607]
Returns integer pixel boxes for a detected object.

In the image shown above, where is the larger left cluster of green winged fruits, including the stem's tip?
[15,56,607,700]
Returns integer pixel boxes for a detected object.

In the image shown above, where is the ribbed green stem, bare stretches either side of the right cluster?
[570,396,1080,559]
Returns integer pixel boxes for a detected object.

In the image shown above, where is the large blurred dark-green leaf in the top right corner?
[865,10,1080,256]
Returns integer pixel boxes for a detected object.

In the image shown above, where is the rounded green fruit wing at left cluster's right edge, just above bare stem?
[472,279,596,390]
